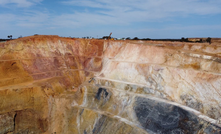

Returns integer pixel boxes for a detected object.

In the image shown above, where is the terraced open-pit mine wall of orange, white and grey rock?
[0,36,221,134]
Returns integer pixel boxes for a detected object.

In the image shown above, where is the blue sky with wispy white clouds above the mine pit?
[0,0,221,38]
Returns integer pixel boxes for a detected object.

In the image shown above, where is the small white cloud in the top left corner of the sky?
[0,0,43,7]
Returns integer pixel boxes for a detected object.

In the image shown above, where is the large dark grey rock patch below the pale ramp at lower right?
[134,97,221,134]
